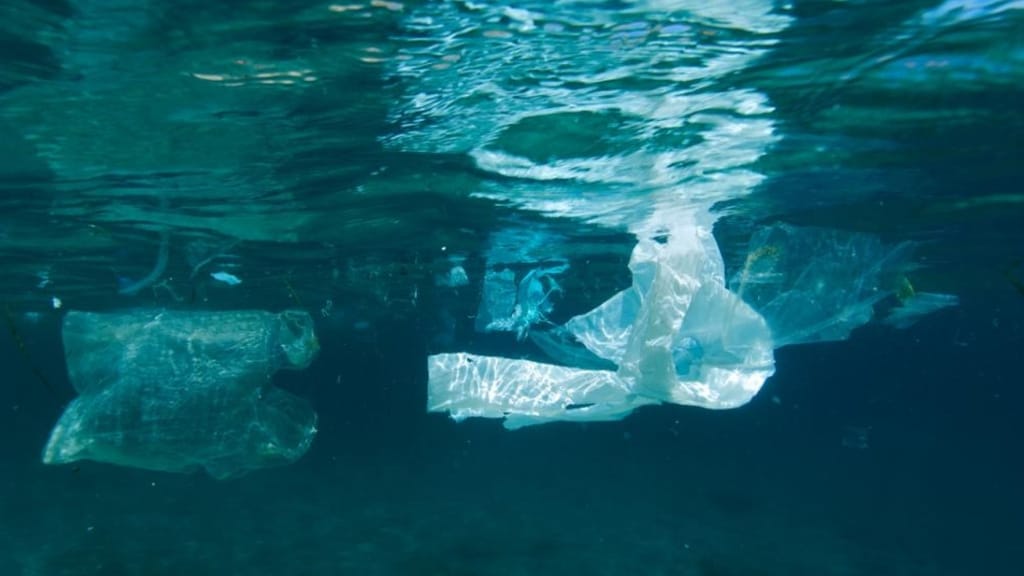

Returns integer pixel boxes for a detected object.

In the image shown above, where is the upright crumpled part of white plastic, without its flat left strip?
[568,227,774,408]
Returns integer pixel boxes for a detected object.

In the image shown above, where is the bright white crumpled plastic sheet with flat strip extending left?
[428,219,774,428]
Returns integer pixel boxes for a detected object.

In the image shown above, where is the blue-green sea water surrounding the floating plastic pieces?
[0,0,1024,576]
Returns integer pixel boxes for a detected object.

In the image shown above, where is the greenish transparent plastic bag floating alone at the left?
[43,311,319,479]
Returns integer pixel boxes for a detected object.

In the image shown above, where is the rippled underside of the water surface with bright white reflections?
[0,0,1024,308]
